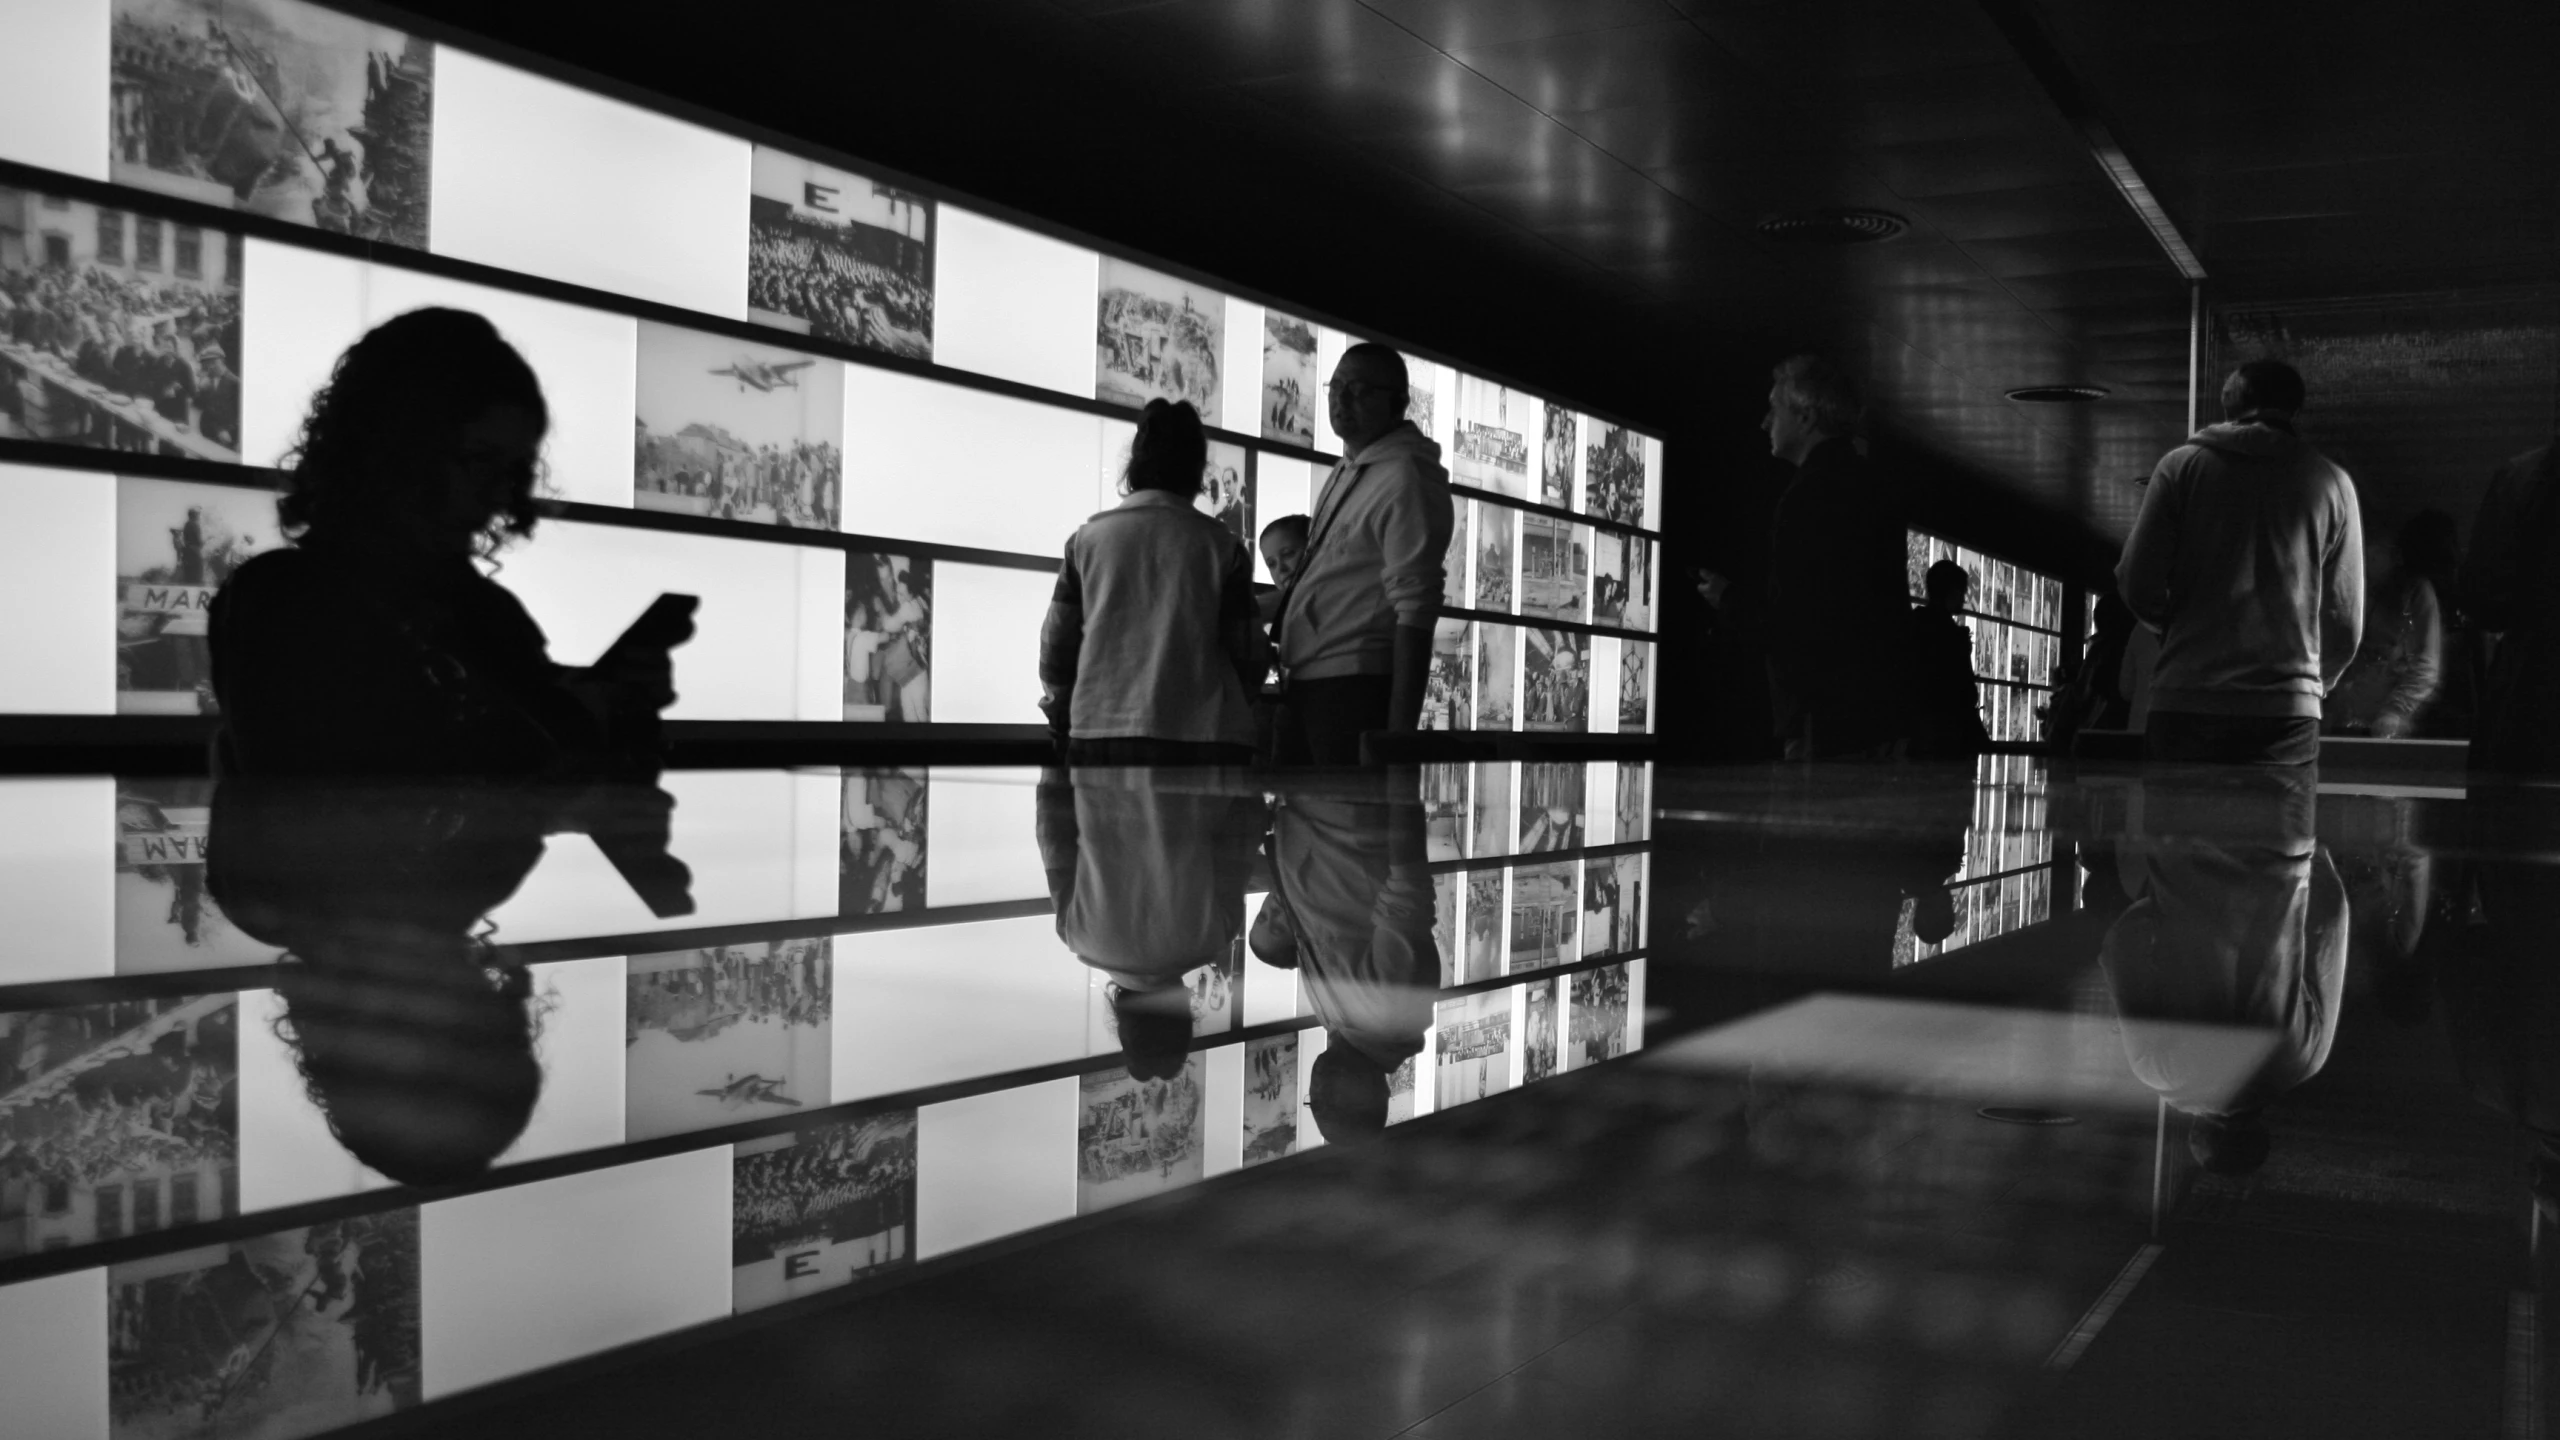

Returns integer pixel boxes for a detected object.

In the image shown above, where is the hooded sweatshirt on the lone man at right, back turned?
[2115,420,2365,720]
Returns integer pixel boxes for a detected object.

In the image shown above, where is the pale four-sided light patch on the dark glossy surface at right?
[1651,994,2273,1115]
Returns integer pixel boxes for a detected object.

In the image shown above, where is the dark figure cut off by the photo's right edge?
[2463,443,2560,779]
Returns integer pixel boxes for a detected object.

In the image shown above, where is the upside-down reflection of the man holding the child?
[1249,769,1439,1143]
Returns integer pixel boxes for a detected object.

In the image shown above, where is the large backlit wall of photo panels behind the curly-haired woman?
[0,0,1658,733]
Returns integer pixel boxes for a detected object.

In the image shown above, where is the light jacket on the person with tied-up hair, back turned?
[1039,489,1270,746]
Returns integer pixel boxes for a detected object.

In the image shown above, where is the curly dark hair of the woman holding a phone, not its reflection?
[276,307,550,553]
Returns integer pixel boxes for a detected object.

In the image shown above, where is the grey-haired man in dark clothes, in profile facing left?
[1761,356,1910,761]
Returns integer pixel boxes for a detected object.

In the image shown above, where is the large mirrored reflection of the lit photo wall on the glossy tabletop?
[0,761,1658,1440]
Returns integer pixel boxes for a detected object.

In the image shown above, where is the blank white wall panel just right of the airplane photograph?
[845,358,1101,556]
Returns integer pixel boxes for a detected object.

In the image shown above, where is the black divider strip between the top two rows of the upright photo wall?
[0,159,1651,530]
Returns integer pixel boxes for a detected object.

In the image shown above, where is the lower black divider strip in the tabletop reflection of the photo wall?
[0,948,1649,1286]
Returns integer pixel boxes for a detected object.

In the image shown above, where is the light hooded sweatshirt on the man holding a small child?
[1275,420,1457,679]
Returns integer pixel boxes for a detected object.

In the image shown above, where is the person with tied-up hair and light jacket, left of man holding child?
[1039,400,1270,766]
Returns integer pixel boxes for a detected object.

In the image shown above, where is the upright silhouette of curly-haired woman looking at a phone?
[212,310,691,774]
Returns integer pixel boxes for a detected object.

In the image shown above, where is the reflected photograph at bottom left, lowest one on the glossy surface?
[108,1207,422,1440]
